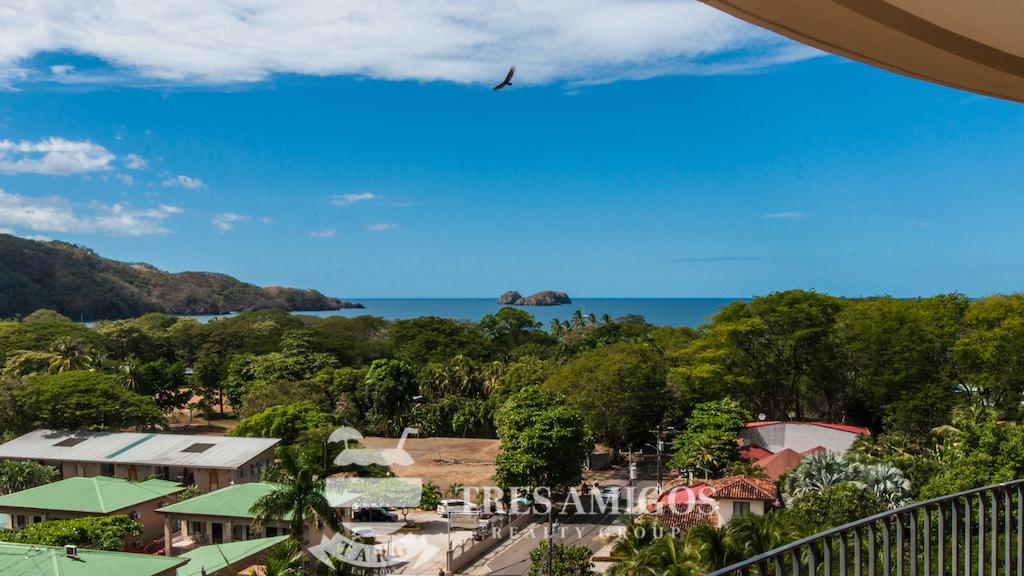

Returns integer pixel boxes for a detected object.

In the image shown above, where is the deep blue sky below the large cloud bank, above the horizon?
[0,4,1024,297]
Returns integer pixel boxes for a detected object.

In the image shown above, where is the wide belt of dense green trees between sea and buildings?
[0,291,1024,574]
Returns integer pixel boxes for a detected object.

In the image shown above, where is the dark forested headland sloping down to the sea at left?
[0,234,356,320]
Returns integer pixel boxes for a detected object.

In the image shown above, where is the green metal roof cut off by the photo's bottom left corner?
[0,542,187,576]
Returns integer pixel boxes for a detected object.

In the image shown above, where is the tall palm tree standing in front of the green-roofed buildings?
[250,448,341,542]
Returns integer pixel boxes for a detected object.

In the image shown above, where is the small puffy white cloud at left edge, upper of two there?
[0,136,116,176]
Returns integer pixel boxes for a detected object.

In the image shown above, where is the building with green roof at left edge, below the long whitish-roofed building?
[0,476,184,549]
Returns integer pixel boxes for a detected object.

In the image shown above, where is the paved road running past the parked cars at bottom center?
[466,496,621,576]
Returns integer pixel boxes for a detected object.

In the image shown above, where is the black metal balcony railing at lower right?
[708,480,1024,576]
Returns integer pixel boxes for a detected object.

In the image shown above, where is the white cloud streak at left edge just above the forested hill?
[0,190,183,236]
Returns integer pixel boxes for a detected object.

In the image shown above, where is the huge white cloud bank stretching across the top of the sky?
[0,0,819,85]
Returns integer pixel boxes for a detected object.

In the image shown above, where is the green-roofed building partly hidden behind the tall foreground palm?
[157,482,357,554]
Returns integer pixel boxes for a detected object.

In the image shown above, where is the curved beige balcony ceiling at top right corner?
[703,0,1024,102]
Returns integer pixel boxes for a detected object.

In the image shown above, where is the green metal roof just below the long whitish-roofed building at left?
[0,476,184,515]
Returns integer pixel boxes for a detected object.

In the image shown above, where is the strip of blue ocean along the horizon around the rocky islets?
[195,298,744,328]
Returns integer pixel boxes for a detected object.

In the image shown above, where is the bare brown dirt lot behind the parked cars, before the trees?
[360,437,500,483]
